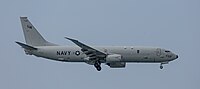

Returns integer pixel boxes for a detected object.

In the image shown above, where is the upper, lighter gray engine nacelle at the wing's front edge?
[106,54,122,63]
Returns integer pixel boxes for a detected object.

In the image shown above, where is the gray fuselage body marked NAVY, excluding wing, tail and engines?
[31,46,176,63]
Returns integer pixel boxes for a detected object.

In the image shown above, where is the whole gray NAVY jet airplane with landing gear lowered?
[16,17,178,71]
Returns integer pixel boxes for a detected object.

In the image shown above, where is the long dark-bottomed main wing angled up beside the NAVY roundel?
[65,37,107,60]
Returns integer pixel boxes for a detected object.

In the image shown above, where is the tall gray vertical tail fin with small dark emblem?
[20,17,56,46]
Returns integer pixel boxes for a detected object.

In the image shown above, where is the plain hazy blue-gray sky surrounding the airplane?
[0,0,200,89]
